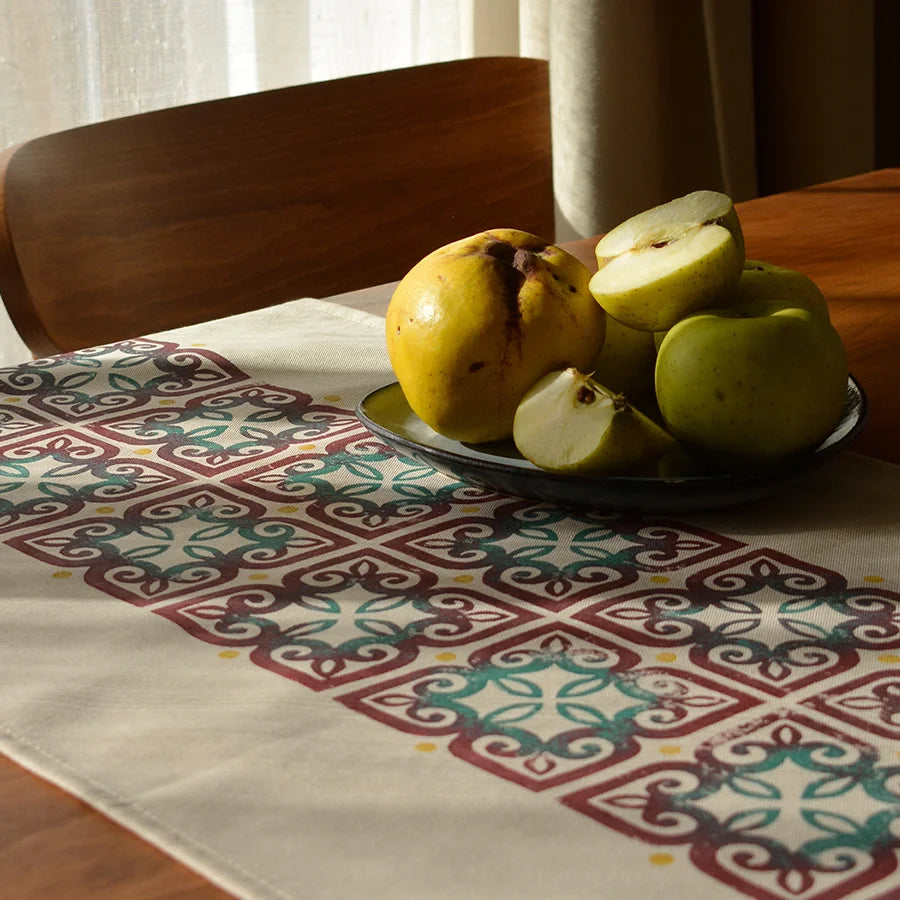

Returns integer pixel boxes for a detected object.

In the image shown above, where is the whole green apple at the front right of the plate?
[656,301,847,472]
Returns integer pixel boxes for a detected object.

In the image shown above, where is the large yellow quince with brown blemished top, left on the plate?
[385,228,606,443]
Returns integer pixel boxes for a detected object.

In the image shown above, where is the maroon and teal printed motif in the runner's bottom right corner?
[564,714,900,900]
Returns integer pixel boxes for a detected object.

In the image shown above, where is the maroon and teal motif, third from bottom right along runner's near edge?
[156,549,535,690]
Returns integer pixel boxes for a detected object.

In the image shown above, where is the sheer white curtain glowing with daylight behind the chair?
[0,0,549,148]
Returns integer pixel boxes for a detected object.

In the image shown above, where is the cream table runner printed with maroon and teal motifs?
[0,300,900,900]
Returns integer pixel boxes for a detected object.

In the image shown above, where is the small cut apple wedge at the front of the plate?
[513,367,673,475]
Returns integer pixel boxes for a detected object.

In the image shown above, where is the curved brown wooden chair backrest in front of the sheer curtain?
[0,57,553,354]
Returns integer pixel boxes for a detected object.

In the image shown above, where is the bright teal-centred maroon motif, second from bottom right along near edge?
[338,624,758,791]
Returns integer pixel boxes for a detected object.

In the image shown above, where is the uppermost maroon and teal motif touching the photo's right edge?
[574,550,900,695]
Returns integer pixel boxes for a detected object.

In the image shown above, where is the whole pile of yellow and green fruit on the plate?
[386,191,848,475]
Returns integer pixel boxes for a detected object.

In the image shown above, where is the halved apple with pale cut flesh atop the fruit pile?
[590,191,744,331]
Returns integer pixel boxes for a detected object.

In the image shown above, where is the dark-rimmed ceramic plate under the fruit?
[356,376,867,513]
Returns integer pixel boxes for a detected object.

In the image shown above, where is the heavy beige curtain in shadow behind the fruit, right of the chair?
[549,0,874,239]
